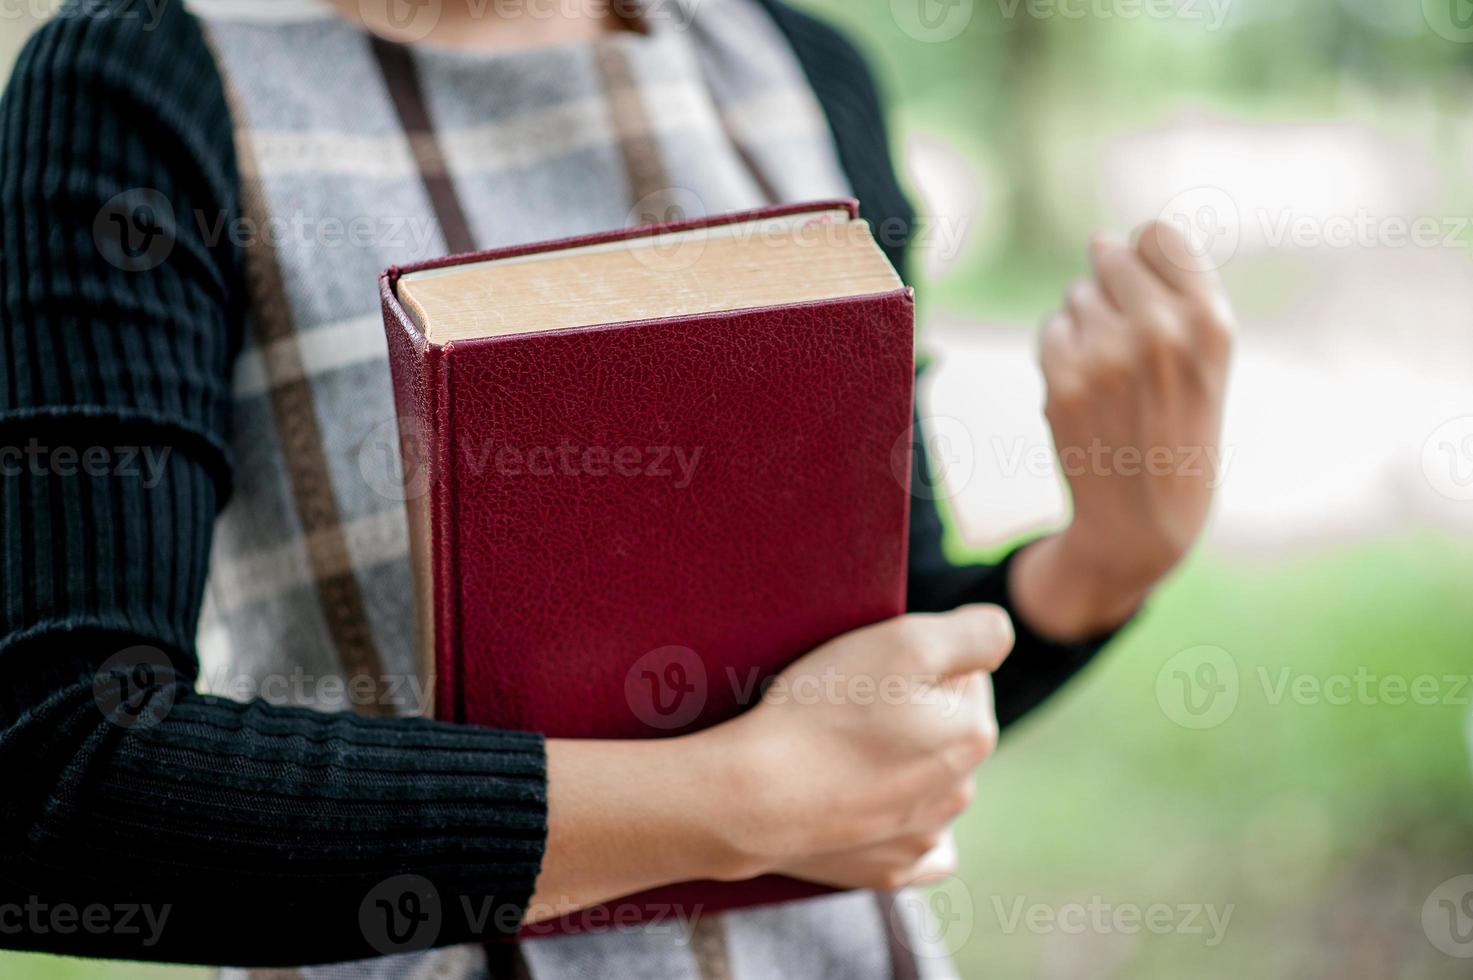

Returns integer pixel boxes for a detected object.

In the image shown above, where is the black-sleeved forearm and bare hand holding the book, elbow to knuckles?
[0,607,1010,965]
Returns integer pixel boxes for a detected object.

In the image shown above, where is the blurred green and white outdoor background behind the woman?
[0,0,1473,980]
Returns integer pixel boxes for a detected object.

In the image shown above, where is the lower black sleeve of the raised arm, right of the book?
[907,403,1118,728]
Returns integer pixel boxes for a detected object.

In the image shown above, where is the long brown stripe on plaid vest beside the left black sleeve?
[204,28,395,715]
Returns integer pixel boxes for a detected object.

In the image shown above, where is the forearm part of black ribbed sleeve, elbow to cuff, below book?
[0,631,546,965]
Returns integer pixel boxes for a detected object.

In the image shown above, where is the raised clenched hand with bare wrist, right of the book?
[1010,223,1234,638]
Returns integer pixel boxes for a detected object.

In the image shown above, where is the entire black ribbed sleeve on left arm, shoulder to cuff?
[0,0,546,965]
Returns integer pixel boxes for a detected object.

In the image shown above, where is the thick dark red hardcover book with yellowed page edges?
[380,200,913,936]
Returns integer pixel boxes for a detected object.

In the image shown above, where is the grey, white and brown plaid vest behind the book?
[191,0,950,980]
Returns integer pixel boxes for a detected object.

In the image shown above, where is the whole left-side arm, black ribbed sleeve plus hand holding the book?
[0,4,1008,965]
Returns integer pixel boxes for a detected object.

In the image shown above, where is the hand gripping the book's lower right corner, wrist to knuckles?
[713,606,1012,887]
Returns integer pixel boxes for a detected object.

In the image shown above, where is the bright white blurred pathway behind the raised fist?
[907,112,1473,551]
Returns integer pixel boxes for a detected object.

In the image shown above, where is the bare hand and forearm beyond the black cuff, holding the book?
[526,606,1012,923]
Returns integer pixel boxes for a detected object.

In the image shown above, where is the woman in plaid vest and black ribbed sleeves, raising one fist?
[0,0,1230,979]
